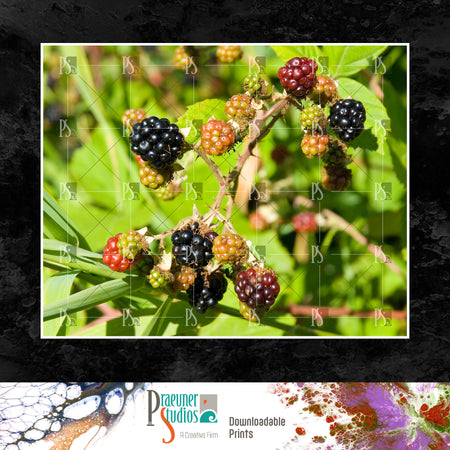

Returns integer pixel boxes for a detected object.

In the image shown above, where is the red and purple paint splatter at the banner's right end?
[268,383,450,450]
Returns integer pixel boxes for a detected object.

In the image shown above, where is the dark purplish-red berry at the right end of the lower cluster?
[234,267,280,308]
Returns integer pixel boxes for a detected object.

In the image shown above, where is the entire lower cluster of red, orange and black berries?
[103,222,280,320]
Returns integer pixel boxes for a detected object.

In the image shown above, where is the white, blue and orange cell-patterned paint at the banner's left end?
[0,383,144,450]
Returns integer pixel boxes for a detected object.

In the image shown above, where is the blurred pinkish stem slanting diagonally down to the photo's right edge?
[294,195,406,278]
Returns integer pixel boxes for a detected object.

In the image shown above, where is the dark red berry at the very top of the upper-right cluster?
[278,57,317,98]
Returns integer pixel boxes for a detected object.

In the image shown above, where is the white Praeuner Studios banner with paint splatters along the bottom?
[0,383,450,450]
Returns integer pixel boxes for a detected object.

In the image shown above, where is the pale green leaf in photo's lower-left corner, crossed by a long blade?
[42,271,79,336]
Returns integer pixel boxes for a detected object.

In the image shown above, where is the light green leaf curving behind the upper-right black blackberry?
[338,78,390,154]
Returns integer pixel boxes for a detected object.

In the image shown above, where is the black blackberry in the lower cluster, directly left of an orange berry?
[172,222,217,268]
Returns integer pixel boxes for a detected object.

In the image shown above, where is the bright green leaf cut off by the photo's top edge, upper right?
[323,45,387,78]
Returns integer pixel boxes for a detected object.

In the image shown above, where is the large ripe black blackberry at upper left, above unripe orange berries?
[129,116,184,169]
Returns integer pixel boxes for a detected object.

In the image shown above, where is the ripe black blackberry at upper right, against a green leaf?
[328,98,366,142]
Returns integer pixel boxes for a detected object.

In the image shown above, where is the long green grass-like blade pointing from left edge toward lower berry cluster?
[44,277,145,320]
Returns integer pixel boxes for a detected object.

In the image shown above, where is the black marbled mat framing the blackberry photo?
[0,0,450,381]
